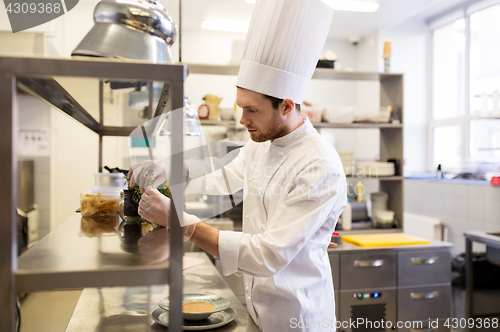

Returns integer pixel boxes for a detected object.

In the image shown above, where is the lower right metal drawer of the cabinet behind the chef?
[398,284,451,321]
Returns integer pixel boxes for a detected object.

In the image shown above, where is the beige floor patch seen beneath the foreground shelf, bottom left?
[21,290,82,332]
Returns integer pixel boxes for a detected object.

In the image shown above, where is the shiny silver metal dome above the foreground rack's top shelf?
[71,0,177,63]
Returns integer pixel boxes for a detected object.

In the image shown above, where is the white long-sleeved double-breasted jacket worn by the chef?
[186,118,347,332]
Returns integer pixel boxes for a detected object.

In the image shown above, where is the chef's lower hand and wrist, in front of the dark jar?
[138,188,200,242]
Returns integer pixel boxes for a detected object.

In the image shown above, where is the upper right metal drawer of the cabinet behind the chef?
[398,251,451,286]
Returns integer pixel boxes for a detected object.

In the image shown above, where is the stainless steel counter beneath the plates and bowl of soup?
[66,253,260,332]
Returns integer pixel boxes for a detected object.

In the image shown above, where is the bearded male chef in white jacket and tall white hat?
[129,0,347,332]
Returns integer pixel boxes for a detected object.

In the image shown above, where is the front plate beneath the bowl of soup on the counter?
[151,308,236,331]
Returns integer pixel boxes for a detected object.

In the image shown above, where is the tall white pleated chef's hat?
[236,0,333,104]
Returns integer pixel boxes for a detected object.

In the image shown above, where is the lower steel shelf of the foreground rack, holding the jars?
[16,213,169,292]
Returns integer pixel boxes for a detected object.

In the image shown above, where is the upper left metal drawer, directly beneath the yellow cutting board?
[340,253,396,290]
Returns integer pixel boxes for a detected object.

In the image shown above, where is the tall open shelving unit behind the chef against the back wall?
[188,64,404,232]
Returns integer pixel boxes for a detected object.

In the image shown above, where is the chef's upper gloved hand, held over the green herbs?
[127,158,170,192]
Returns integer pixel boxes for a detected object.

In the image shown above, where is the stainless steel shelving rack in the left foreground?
[0,57,187,332]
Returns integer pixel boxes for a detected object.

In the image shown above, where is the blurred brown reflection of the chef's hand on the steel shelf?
[137,228,170,264]
